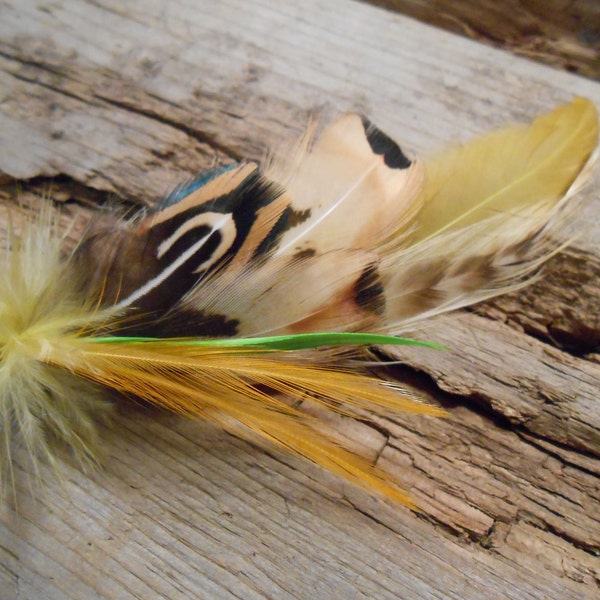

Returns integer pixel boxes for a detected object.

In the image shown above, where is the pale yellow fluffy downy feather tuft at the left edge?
[0,209,118,496]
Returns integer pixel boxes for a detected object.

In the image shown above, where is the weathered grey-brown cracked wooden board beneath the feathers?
[0,0,600,600]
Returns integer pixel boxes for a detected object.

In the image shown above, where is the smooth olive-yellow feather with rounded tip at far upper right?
[412,98,598,244]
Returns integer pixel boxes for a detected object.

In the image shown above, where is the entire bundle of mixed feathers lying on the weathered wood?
[0,99,598,505]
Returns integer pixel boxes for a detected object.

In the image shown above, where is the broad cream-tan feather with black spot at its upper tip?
[265,115,423,256]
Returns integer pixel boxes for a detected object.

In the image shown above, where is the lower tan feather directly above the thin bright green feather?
[181,250,377,336]
